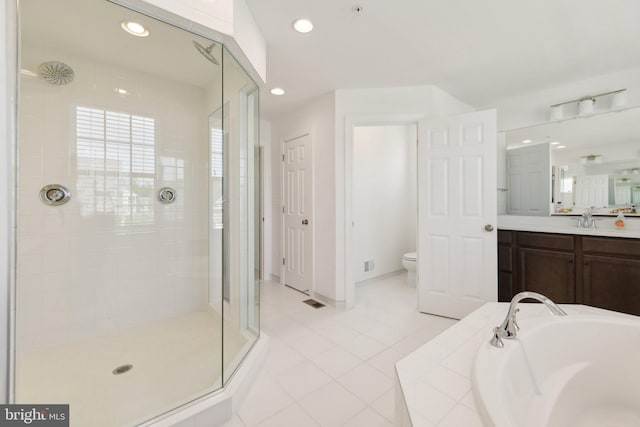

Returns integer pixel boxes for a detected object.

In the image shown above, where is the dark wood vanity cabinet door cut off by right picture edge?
[583,255,640,315]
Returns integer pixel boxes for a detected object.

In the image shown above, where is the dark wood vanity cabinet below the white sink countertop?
[498,230,640,315]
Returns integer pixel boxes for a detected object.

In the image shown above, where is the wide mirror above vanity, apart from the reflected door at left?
[505,107,640,215]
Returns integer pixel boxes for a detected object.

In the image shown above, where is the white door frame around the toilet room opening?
[343,114,425,308]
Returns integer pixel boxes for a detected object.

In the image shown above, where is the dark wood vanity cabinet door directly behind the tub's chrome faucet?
[518,248,576,303]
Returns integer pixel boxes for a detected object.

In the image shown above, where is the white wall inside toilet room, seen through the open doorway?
[353,125,417,283]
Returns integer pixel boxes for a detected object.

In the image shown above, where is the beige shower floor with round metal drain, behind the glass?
[16,311,246,427]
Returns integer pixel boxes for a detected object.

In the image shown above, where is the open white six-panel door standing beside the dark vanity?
[417,110,498,319]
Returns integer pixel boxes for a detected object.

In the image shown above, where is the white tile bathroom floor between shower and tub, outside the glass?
[225,274,460,427]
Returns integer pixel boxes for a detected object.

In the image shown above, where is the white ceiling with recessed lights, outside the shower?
[247,0,640,119]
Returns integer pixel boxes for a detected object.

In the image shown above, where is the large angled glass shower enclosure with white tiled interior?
[11,0,260,426]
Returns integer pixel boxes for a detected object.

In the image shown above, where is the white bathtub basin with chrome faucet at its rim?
[472,312,640,427]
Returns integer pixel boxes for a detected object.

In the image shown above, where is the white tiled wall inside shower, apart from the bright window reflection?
[17,48,209,351]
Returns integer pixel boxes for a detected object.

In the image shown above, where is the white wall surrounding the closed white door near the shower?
[271,93,335,298]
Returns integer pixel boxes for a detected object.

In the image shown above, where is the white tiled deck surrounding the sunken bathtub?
[396,302,626,427]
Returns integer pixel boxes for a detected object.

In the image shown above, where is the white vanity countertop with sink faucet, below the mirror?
[498,215,640,239]
